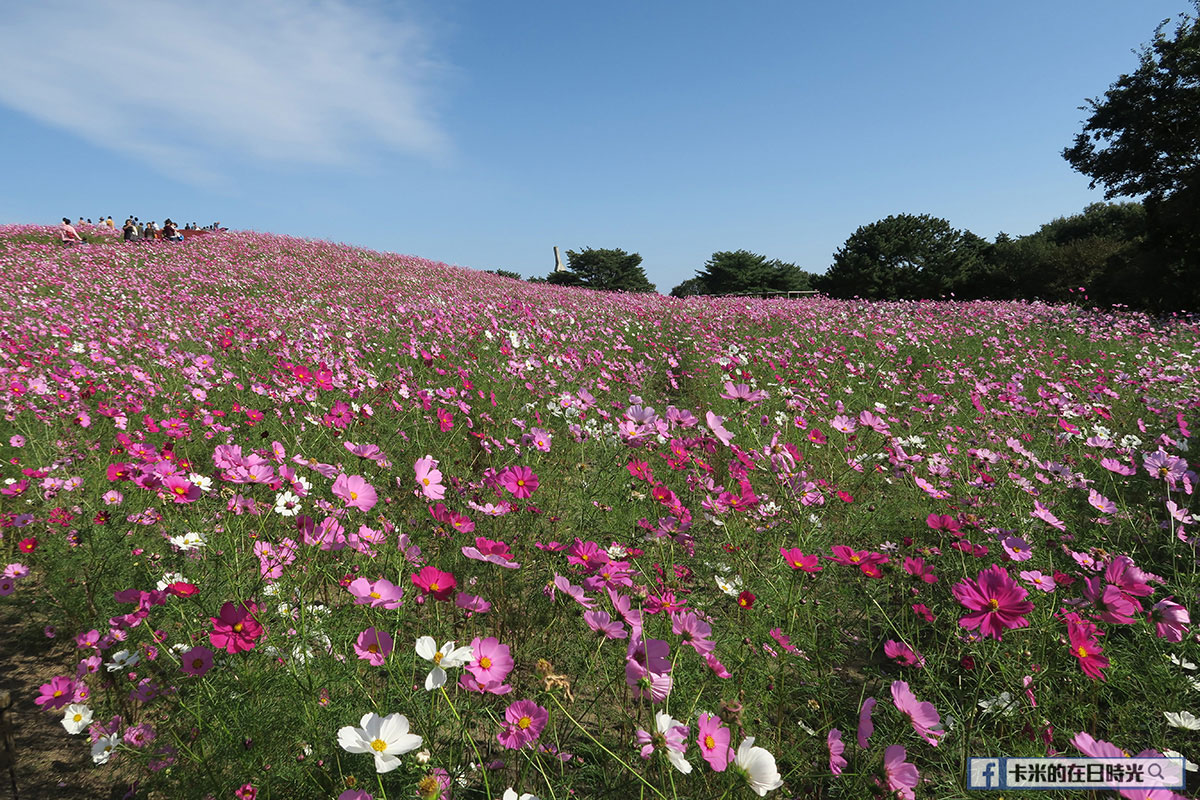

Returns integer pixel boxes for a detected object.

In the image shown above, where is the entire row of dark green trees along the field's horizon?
[533,7,1200,313]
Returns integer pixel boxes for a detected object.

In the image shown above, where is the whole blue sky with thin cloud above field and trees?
[0,0,1192,291]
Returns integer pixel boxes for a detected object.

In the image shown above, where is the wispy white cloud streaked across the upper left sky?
[0,0,448,180]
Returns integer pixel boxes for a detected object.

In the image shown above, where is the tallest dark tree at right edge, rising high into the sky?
[1062,0,1200,311]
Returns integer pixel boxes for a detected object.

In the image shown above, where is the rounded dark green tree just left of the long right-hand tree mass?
[816,213,990,300]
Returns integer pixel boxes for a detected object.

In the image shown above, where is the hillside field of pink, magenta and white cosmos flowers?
[0,227,1200,800]
